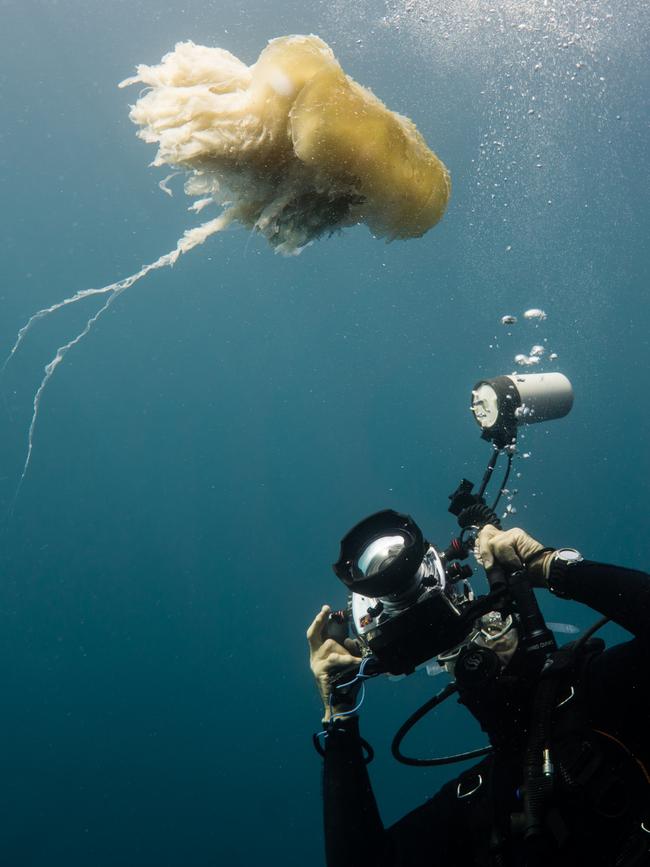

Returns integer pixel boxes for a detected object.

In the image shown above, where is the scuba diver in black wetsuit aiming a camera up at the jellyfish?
[307,513,650,867]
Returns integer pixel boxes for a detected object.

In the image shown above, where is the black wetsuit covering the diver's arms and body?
[323,561,650,867]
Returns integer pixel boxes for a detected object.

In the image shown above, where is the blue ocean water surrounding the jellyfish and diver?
[0,0,650,867]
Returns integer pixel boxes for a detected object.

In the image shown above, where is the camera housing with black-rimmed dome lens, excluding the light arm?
[334,510,473,674]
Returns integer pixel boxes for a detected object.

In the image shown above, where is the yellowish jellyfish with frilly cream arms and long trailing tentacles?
[3,35,450,487]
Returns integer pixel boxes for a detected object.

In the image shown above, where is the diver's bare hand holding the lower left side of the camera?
[307,605,361,722]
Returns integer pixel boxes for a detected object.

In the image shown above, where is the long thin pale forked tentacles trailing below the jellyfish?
[14,207,237,502]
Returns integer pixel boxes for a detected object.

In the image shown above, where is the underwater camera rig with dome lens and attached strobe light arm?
[328,373,573,679]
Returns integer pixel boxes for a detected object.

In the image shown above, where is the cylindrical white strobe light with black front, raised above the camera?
[471,373,573,448]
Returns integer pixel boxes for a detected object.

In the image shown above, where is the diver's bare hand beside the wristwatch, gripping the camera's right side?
[475,524,553,587]
